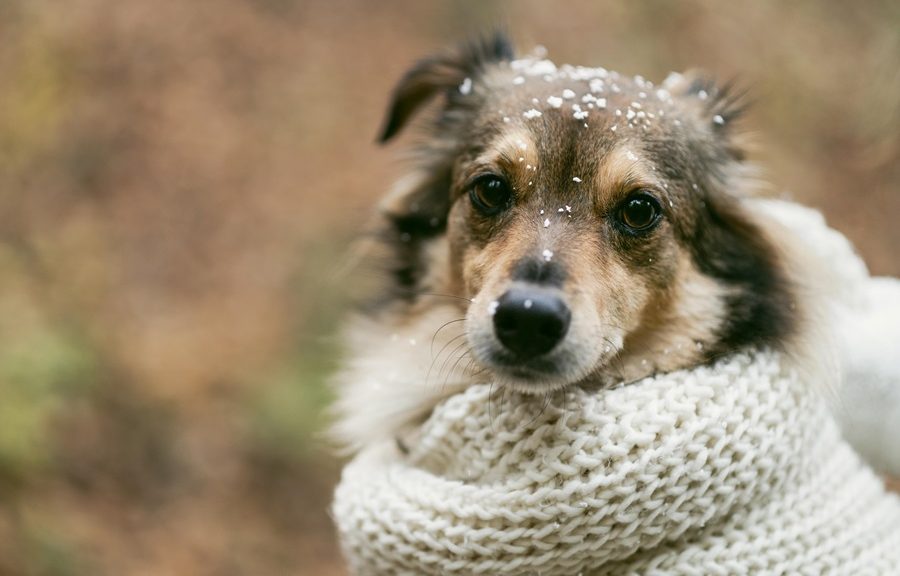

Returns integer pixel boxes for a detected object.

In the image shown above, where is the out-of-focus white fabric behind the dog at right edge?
[754,200,900,476]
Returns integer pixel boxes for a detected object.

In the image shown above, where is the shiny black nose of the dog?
[494,288,572,358]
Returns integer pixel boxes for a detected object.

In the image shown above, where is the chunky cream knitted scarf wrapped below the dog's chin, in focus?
[332,201,900,576]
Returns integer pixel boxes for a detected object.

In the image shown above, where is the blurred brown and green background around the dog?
[0,0,900,576]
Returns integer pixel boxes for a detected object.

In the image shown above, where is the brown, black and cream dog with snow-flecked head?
[335,34,806,446]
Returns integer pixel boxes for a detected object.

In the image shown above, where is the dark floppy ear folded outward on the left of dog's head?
[378,31,514,142]
